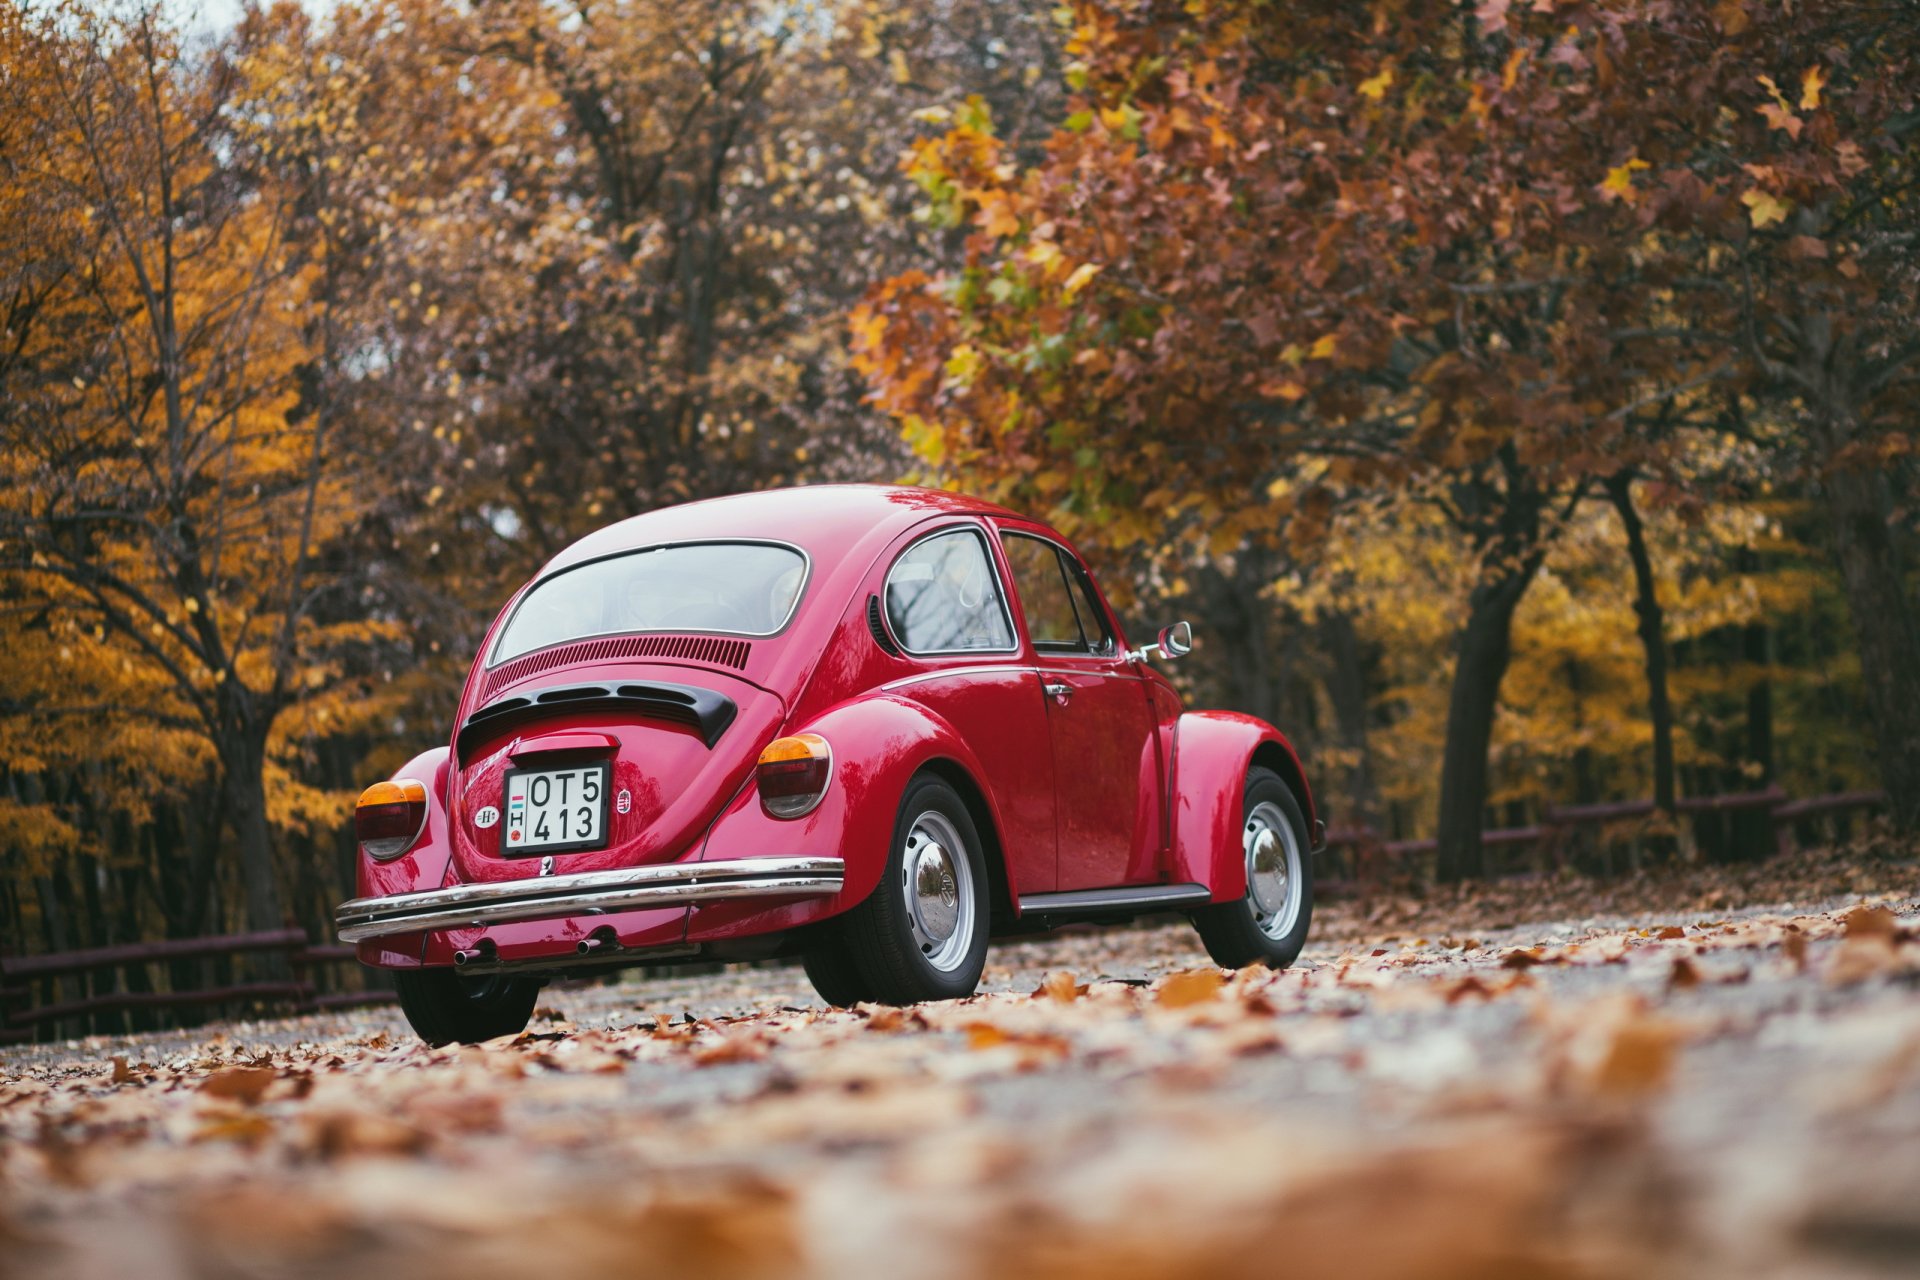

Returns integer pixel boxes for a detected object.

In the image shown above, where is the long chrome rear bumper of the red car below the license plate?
[334,858,847,942]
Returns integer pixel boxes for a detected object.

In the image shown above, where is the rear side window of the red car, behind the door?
[887,528,1014,654]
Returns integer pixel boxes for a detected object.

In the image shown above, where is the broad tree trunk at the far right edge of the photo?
[1826,466,1920,835]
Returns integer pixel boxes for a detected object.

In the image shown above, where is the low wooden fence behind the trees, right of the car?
[1317,787,1887,892]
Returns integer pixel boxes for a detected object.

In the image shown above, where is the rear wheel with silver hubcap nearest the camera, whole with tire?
[829,773,987,1004]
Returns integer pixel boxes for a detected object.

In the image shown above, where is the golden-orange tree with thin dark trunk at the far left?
[0,6,390,929]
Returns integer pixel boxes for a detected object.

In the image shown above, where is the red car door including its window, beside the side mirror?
[1000,526,1160,892]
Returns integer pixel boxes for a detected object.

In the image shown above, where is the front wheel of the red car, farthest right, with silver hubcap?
[1192,766,1313,969]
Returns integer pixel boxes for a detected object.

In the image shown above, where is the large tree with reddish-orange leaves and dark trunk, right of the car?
[852,0,1912,877]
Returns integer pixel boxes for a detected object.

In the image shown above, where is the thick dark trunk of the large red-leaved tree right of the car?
[1436,553,1540,883]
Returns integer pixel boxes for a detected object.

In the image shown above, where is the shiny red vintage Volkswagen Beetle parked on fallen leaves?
[336,486,1321,1044]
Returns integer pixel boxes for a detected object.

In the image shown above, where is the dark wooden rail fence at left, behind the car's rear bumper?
[0,929,394,1042]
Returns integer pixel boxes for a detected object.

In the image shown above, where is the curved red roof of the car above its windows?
[540,484,1021,578]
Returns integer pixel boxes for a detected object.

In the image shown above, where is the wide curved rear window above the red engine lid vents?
[488,543,806,666]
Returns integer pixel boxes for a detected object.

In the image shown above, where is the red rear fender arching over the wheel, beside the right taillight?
[687,697,1020,940]
